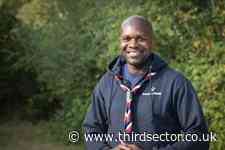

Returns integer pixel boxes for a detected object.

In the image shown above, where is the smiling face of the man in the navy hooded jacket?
[120,18,152,67]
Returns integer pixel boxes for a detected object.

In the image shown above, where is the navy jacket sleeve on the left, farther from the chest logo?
[83,81,111,150]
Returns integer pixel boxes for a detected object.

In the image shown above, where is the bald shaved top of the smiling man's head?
[121,15,153,36]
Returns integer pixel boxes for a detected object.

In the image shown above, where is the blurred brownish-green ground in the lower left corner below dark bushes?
[0,122,84,150]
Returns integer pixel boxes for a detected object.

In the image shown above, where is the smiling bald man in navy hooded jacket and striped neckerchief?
[83,16,208,150]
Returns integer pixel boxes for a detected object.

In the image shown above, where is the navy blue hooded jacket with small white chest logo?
[83,53,209,150]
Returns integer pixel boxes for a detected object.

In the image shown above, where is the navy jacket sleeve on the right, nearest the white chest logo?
[158,76,209,150]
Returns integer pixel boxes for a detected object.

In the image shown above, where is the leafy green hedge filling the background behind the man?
[0,0,225,150]
